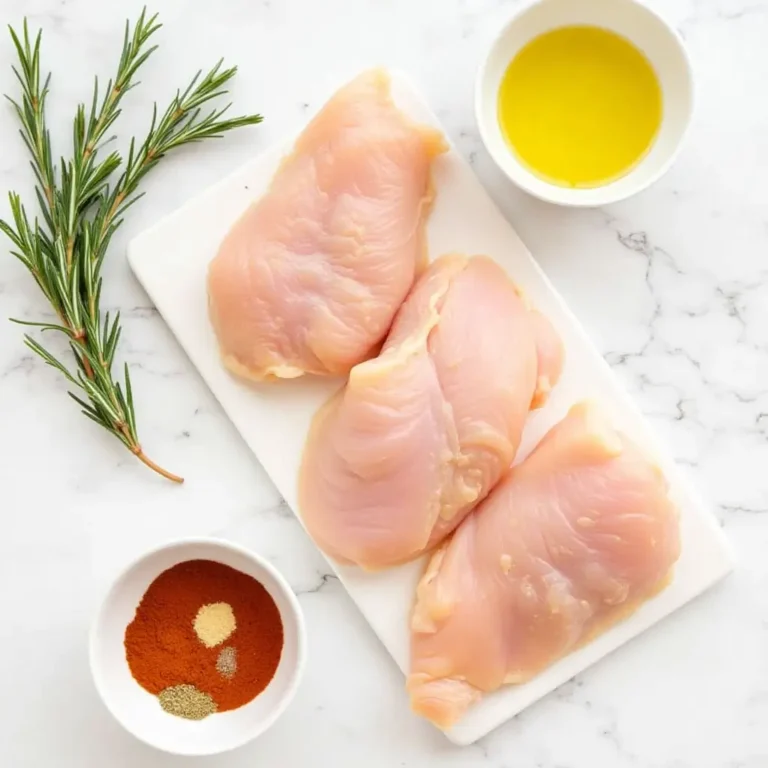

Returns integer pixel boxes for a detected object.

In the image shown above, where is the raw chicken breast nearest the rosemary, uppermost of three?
[208,71,446,380]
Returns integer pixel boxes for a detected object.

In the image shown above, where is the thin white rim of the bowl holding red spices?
[88,536,307,757]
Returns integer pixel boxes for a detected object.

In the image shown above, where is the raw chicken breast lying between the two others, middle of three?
[300,255,562,570]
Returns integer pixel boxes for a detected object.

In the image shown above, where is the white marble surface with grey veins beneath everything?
[0,0,768,768]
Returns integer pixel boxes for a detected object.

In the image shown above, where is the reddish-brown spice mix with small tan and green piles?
[125,560,283,720]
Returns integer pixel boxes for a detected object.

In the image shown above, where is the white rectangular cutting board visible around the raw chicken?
[128,74,732,744]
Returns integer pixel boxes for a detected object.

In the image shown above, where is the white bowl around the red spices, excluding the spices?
[90,539,306,755]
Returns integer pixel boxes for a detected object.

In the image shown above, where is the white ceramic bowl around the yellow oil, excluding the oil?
[475,0,693,206]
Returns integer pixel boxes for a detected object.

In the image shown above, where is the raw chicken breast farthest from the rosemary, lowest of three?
[407,403,680,728]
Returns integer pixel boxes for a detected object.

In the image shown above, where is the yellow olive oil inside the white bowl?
[498,26,663,187]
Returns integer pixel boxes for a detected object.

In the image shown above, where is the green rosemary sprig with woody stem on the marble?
[0,11,262,482]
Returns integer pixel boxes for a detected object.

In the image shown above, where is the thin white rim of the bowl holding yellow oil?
[474,0,696,208]
